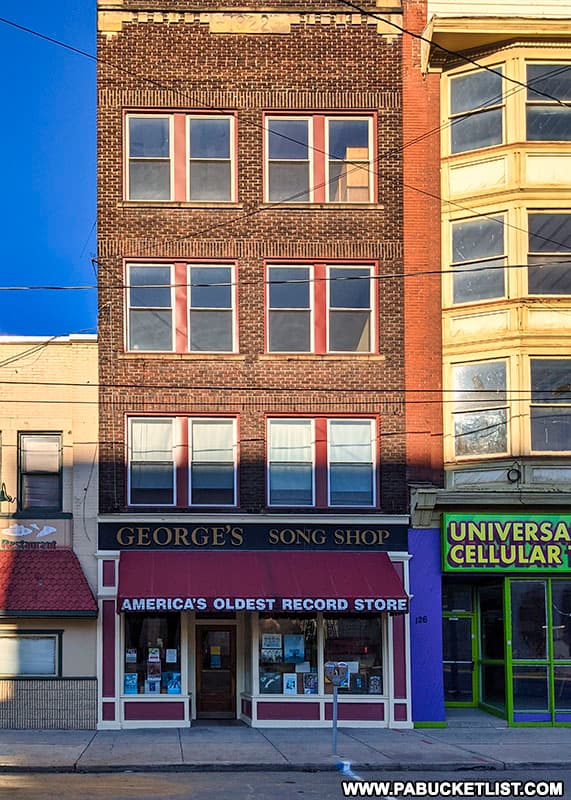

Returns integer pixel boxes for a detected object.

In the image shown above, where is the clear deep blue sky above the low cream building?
[0,0,97,335]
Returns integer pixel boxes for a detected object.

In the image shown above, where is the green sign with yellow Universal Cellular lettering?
[442,514,571,573]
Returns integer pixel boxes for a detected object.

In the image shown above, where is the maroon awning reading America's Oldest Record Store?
[118,551,408,613]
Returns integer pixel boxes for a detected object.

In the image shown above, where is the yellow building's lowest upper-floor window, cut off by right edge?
[530,358,571,453]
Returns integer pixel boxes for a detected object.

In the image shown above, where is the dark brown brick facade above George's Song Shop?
[98,10,412,512]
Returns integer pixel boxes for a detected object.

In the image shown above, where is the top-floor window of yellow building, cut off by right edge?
[526,64,571,141]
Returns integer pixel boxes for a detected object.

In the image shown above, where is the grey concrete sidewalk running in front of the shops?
[0,717,571,773]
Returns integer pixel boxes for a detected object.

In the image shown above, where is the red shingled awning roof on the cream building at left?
[0,548,97,617]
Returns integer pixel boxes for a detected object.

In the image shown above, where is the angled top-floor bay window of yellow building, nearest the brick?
[450,66,503,153]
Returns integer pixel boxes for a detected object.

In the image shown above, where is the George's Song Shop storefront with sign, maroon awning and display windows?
[98,517,411,728]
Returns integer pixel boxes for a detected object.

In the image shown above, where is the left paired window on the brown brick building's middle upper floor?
[126,262,236,353]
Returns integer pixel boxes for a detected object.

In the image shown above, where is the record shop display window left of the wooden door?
[123,614,182,695]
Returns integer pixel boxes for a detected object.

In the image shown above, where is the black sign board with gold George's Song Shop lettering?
[99,521,408,552]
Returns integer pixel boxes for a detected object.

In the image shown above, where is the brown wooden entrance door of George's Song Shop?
[196,625,236,719]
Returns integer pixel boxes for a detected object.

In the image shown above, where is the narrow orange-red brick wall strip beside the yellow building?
[403,0,443,484]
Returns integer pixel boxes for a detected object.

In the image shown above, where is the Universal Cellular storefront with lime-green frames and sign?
[442,514,571,725]
